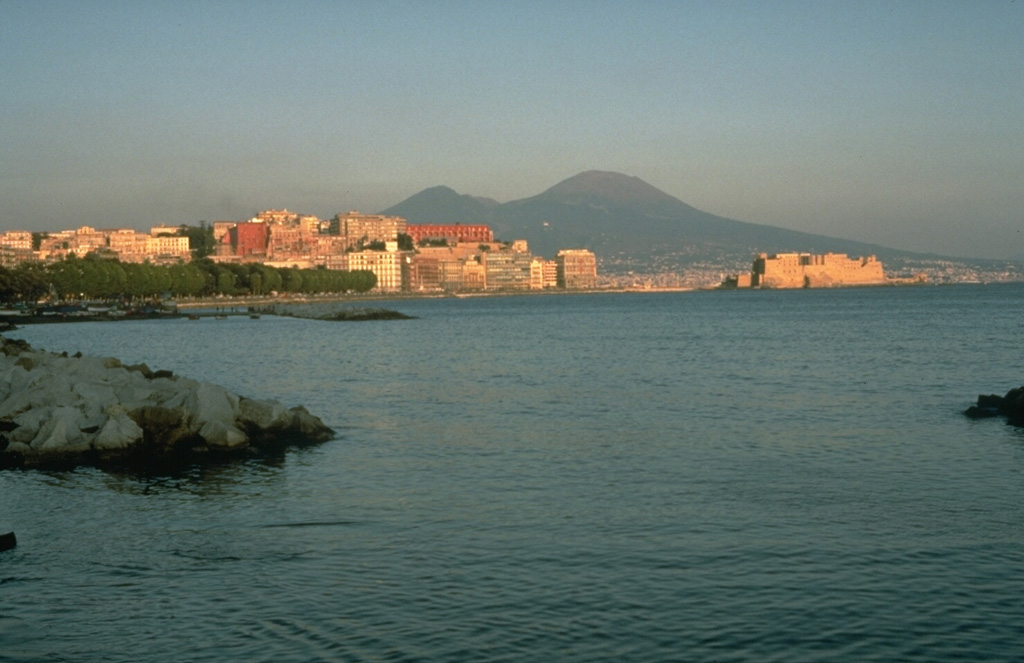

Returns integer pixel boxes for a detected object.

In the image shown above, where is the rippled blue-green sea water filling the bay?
[0,285,1024,662]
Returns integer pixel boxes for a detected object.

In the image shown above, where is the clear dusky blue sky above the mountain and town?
[0,0,1024,258]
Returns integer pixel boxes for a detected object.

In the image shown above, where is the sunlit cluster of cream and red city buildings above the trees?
[0,209,598,293]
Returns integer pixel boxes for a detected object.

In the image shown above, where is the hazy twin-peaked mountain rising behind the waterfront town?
[383,170,937,273]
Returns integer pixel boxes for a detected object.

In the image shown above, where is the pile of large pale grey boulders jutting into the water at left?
[0,337,334,468]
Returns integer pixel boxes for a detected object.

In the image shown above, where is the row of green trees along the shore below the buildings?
[0,253,377,303]
